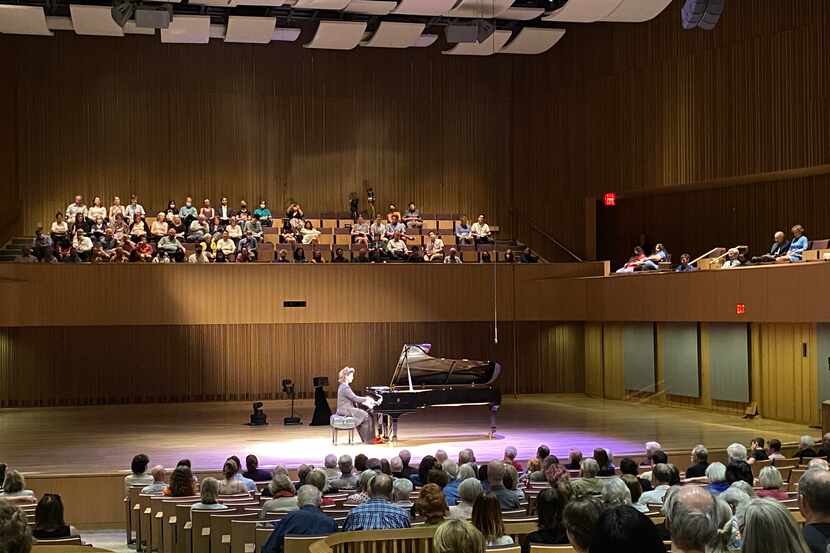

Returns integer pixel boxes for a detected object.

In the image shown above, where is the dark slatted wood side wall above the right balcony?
[513,0,830,256]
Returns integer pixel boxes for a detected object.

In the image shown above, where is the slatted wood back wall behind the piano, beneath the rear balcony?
[0,321,584,406]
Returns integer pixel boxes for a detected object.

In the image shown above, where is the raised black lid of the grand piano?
[390,344,501,388]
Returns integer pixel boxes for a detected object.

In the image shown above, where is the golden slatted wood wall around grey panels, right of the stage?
[584,323,820,425]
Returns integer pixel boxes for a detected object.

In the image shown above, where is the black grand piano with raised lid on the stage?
[366,344,501,442]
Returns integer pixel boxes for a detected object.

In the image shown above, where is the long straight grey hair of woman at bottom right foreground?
[742,499,810,553]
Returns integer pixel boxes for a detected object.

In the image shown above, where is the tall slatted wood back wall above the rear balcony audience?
[0,33,511,233]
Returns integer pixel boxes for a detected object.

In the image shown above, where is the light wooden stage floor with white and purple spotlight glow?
[0,395,816,474]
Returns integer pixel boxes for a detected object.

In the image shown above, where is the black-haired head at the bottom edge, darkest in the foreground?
[591,505,668,553]
